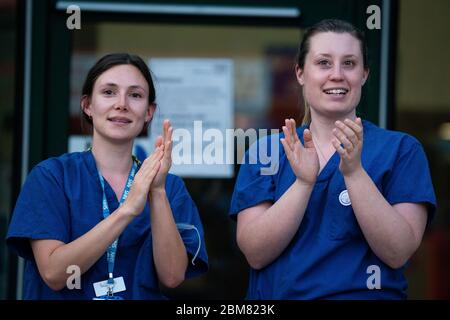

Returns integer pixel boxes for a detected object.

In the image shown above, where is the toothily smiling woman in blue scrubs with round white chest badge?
[230,20,436,299]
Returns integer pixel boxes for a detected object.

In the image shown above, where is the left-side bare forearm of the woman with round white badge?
[238,179,314,269]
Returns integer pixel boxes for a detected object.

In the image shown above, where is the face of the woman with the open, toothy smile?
[296,32,369,126]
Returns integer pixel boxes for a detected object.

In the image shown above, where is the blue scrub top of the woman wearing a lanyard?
[7,151,208,299]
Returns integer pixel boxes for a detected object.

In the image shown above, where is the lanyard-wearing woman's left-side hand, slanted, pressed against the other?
[122,146,164,217]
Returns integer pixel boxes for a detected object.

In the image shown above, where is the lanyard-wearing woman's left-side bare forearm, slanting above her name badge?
[39,207,133,290]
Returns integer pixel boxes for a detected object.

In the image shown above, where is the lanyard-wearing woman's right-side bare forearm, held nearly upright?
[150,189,188,288]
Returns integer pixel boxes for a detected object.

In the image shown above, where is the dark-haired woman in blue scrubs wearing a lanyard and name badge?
[7,54,207,299]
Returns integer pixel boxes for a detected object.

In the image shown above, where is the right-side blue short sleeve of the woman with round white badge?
[384,136,436,224]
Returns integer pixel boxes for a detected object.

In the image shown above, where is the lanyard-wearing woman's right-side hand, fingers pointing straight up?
[150,119,173,192]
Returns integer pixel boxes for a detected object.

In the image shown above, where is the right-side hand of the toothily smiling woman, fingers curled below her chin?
[331,118,363,176]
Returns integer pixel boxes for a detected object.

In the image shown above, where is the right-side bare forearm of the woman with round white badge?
[344,168,417,268]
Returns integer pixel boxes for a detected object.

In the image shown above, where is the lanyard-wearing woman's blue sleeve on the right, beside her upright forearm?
[168,175,208,278]
